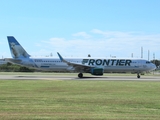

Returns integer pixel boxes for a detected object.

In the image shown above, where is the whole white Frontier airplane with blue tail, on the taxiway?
[5,36,156,78]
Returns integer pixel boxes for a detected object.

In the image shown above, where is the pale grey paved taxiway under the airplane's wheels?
[0,75,160,82]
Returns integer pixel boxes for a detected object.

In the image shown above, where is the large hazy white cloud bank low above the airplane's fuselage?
[34,29,160,59]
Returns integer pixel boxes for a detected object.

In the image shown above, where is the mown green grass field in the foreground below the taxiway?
[0,80,160,120]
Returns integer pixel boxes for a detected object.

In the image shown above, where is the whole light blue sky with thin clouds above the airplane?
[0,0,160,59]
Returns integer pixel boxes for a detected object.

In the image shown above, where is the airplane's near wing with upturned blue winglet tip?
[57,52,95,71]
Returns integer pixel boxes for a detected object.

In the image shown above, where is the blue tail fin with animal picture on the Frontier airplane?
[7,36,30,58]
